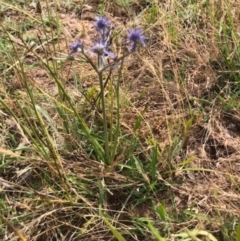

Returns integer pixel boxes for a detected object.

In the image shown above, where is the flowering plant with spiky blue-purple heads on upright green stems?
[69,17,147,164]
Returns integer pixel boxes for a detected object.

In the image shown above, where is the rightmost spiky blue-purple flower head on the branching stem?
[127,29,147,52]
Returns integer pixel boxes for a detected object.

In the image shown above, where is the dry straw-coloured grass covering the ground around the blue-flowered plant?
[0,0,240,241]
